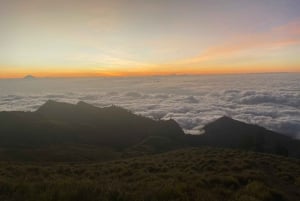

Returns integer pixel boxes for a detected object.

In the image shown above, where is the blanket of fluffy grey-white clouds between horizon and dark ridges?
[0,73,300,138]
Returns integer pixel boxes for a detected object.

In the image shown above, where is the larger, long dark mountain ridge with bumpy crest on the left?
[0,101,184,161]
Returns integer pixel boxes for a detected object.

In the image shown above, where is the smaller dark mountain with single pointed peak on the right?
[187,116,300,158]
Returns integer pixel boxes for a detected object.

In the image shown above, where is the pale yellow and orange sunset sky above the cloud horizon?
[0,0,300,78]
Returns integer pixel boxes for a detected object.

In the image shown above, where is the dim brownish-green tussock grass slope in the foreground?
[0,148,300,201]
